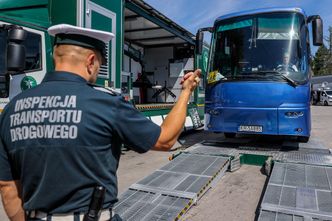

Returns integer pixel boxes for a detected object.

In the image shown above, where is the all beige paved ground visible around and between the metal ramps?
[0,106,332,221]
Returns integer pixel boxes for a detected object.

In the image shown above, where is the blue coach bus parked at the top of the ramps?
[196,8,323,142]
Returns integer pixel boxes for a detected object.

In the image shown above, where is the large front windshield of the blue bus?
[208,12,309,85]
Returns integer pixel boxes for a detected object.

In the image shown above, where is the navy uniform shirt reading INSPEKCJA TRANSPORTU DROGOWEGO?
[0,72,160,213]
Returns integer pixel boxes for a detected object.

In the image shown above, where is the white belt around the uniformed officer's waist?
[26,208,113,221]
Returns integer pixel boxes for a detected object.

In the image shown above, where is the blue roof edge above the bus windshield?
[216,7,306,22]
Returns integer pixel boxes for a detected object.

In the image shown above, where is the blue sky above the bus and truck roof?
[144,0,332,52]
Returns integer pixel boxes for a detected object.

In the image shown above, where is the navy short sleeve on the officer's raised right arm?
[113,98,161,153]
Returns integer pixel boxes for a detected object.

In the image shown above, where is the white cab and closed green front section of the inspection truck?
[0,0,123,109]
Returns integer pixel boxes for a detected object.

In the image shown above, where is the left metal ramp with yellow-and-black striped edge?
[114,153,229,221]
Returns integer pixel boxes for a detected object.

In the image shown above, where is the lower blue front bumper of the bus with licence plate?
[205,105,311,136]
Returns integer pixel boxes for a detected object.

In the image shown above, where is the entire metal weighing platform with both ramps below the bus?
[114,139,332,221]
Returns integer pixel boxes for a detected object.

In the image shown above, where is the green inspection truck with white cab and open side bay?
[0,0,207,128]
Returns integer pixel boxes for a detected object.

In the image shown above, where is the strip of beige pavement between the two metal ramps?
[184,165,266,221]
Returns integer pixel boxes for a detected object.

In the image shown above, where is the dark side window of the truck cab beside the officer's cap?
[24,32,42,72]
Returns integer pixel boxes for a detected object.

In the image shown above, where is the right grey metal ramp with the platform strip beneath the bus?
[187,142,332,221]
